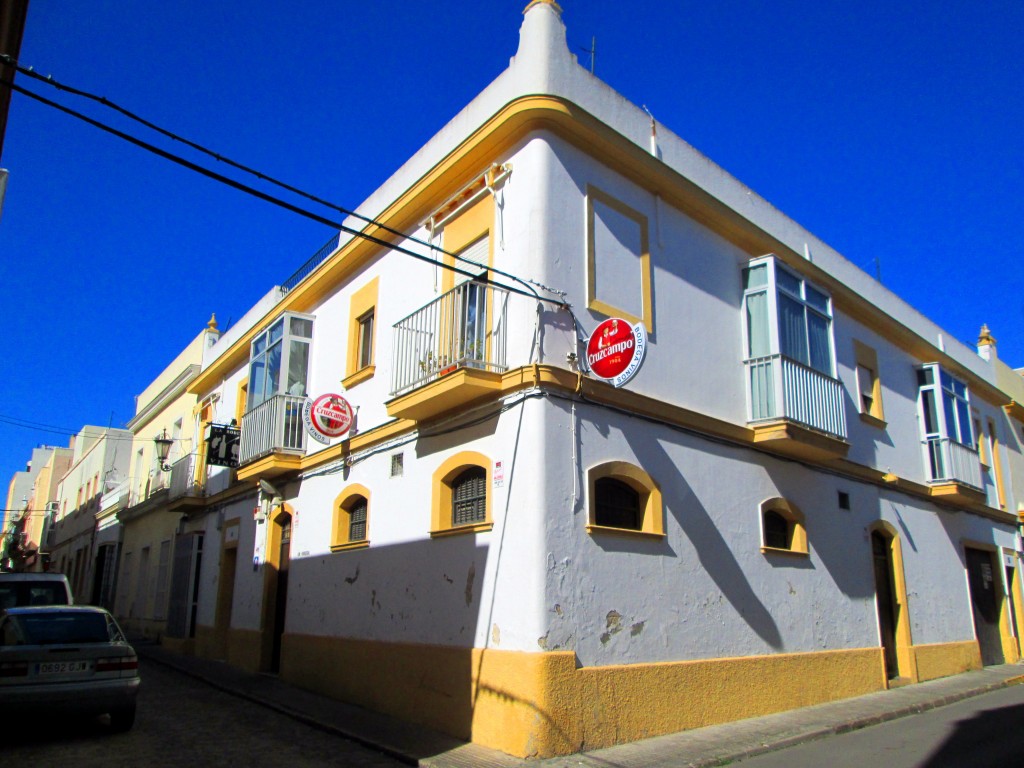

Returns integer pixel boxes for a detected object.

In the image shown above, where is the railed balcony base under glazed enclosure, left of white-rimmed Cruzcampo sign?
[239,394,306,479]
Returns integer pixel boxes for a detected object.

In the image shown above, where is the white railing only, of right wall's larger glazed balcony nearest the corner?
[746,354,846,440]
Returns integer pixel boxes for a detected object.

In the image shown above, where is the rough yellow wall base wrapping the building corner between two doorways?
[282,635,885,757]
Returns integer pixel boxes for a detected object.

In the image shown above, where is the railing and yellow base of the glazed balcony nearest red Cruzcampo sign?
[745,354,849,456]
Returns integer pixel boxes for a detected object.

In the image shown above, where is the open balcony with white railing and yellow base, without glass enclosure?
[388,281,510,421]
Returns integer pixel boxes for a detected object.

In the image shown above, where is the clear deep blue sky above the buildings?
[0,0,1024,487]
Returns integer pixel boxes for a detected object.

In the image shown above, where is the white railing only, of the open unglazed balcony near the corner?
[391,281,509,396]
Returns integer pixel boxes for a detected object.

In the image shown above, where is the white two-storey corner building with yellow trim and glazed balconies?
[161,0,1024,756]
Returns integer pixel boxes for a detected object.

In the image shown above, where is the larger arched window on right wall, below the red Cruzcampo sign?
[587,462,665,536]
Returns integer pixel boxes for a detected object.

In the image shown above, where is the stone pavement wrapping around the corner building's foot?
[135,642,1024,768]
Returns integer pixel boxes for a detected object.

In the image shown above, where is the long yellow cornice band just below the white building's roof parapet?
[188,95,1012,421]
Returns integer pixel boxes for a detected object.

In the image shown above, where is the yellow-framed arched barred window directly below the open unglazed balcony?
[430,451,493,536]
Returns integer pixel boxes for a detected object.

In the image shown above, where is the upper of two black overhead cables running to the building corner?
[0,53,565,303]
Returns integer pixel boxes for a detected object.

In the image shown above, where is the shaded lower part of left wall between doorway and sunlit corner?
[282,532,489,740]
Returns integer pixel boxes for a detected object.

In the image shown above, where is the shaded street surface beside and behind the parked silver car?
[2,659,403,768]
